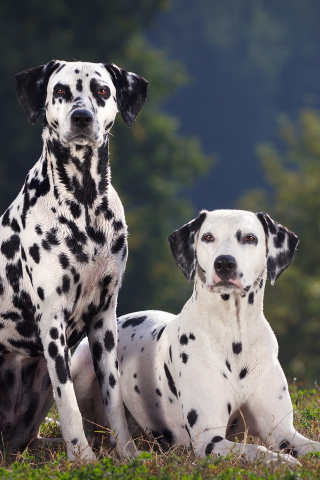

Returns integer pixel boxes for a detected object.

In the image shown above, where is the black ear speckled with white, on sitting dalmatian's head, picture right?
[104,63,149,127]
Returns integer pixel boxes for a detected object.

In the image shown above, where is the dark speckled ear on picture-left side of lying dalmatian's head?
[168,210,208,282]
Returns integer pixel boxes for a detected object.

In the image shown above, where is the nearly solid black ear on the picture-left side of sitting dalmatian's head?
[15,60,60,125]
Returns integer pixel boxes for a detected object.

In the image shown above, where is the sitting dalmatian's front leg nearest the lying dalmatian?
[88,295,139,457]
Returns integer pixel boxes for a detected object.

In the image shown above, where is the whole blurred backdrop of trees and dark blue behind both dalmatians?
[0,0,320,382]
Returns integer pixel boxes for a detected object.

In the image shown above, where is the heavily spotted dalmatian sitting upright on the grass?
[0,60,148,460]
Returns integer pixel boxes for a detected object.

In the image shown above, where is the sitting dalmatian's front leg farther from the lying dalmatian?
[40,314,95,461]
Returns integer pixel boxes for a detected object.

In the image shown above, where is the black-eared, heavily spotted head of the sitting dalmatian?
[16,60,148,146]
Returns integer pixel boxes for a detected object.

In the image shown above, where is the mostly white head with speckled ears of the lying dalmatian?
[169,210,299,293]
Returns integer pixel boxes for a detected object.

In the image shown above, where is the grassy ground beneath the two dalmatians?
[0,384,320,480]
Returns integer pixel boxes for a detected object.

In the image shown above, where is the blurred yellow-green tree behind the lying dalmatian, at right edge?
[239,110,320,381]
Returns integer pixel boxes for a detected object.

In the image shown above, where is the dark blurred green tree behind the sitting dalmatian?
[0,0,210,313]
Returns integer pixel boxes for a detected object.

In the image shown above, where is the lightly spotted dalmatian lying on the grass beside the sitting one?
[71,210,320,465]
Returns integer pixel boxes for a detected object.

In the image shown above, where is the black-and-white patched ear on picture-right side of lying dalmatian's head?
[256,212,299,285]
